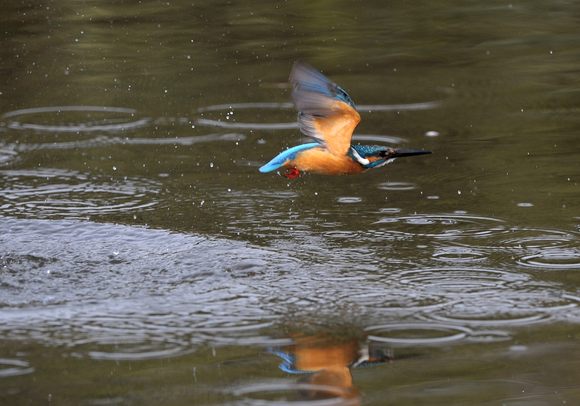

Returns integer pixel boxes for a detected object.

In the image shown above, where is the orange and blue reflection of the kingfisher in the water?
[271,336,392,405]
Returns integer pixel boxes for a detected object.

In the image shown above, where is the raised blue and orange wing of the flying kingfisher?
[290,62,360,156]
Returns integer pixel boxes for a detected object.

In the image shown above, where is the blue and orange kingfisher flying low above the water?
[260,61,431,179]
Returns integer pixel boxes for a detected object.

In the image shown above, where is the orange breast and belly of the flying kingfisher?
[286,147,364,175]
